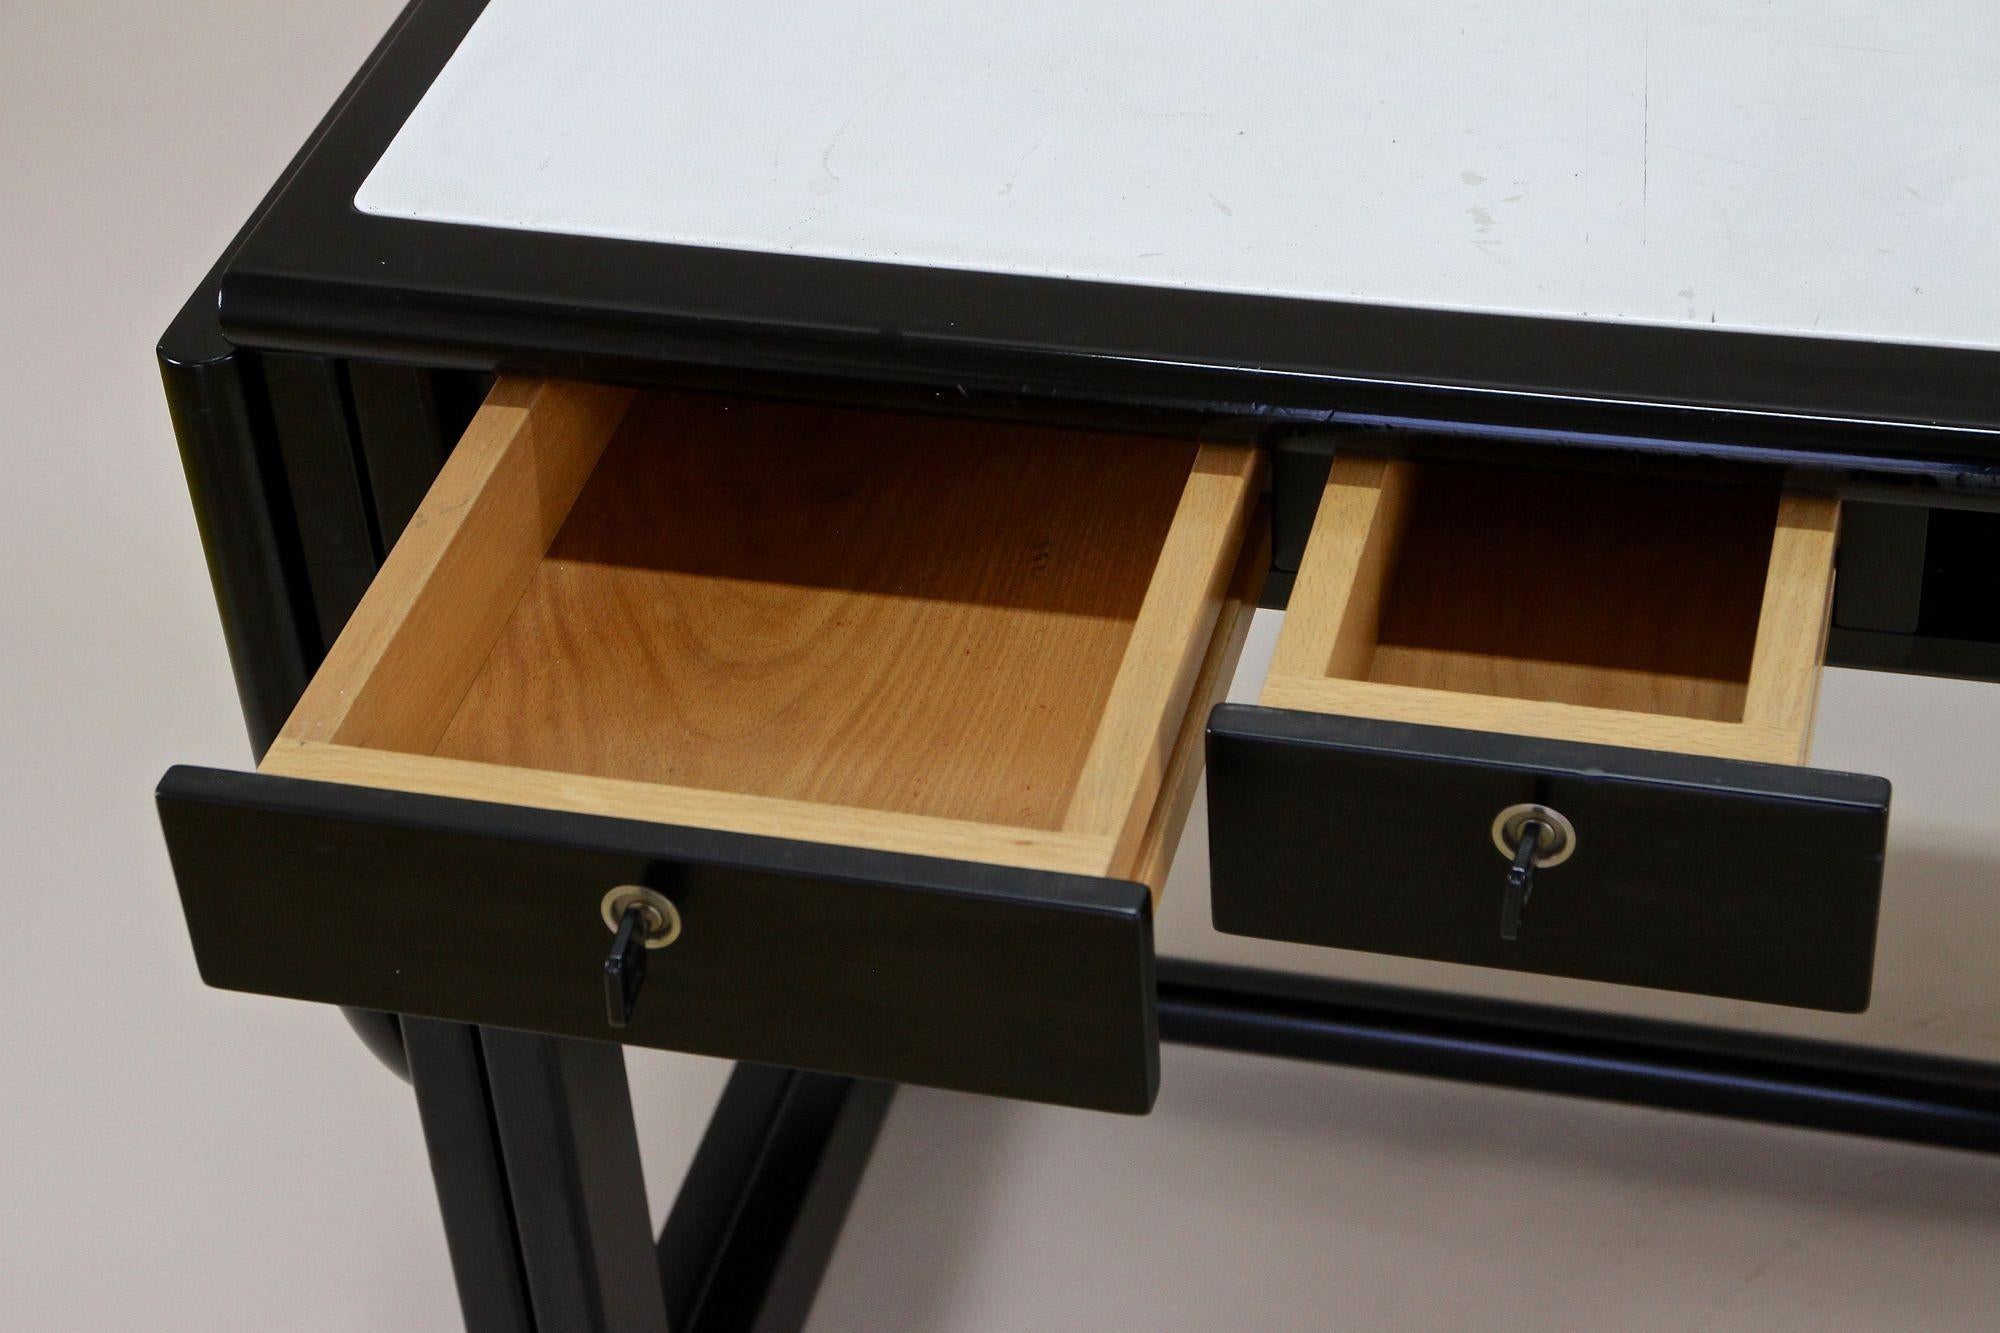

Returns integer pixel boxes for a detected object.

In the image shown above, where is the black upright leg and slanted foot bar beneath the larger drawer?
[402,1019,894,1333]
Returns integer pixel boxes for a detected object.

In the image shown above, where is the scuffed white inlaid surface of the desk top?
[356,0,2000,348]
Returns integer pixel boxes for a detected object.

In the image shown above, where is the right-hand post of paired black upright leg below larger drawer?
[480,1029,666,1333]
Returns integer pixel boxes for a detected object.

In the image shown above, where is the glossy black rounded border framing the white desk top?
[222,0,2000,494]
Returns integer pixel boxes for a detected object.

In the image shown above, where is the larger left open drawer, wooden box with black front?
[160,380,1266,1111]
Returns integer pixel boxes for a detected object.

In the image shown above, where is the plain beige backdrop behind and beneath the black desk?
[0,0,2000,1329]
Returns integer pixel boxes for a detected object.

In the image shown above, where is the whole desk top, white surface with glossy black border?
[218,0,2000,478]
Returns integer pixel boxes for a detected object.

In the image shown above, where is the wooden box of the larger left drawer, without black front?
[262,380,1262,887]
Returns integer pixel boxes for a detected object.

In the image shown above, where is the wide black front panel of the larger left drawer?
[158,769,1160,1113]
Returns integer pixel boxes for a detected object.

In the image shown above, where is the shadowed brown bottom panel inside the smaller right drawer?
[1366,466,1778,721]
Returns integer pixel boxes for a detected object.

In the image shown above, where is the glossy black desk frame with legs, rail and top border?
[160,0,2000,1329]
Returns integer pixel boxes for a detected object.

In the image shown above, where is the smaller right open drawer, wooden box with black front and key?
[1210,456,1888,1011]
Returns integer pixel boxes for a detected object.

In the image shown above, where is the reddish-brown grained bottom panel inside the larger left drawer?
[434,394,1220,829]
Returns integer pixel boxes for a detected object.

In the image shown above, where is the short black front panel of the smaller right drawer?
[1208,705,1888,1013]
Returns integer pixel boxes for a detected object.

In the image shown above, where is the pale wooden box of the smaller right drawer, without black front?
[1262,456,1840,763]
